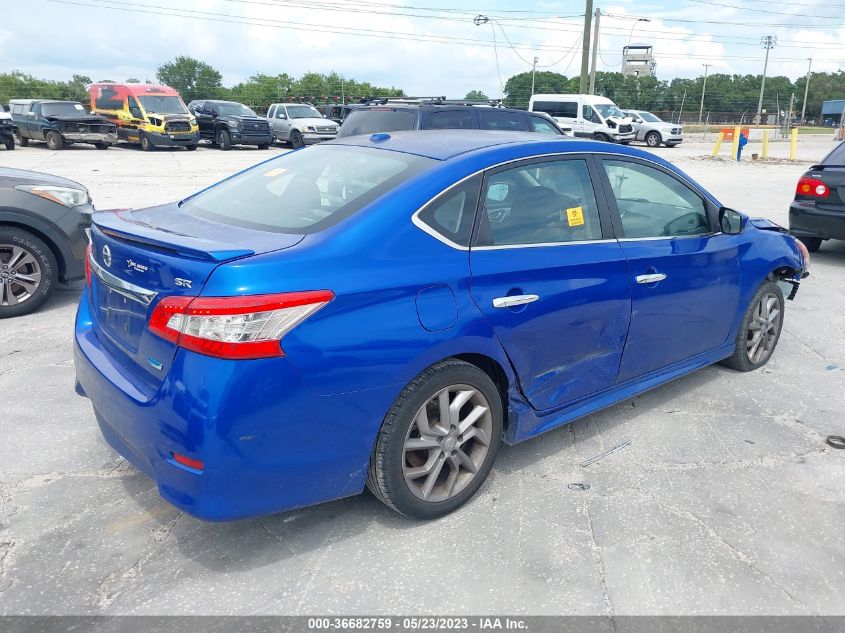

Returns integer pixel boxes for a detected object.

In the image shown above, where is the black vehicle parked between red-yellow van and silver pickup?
[188,101,273,150]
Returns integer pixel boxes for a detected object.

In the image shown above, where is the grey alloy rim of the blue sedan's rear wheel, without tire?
[402,385,493,502]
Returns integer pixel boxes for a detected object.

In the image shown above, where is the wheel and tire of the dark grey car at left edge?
[0,227,59,319]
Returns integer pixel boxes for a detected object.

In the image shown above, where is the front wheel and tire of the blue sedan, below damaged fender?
[721,281,785,371]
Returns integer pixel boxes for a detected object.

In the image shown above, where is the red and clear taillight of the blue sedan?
[148,290,334,359]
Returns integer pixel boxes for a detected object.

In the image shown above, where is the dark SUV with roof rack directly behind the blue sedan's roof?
[337,99,563,138]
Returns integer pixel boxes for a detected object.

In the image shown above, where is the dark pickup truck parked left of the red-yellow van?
[9,99,117,150]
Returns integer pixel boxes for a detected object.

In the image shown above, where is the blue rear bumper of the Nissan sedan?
[74,288,395,521]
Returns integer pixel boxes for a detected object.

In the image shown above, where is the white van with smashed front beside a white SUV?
[528,94,636,144]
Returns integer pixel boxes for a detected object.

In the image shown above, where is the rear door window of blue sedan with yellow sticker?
[476,159,602,246]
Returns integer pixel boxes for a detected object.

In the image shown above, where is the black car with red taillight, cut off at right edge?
[789,143,845,252]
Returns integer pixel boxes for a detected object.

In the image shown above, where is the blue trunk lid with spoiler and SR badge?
[89,204,303,388]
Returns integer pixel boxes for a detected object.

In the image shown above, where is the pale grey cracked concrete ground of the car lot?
[0,137,845,615]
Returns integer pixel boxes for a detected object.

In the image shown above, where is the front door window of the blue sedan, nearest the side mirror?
[601,159,710,238]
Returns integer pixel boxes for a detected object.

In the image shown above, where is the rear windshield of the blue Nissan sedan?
[181,145,437,233]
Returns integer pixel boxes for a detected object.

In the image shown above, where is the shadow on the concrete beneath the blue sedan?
[124,367,722,572]
